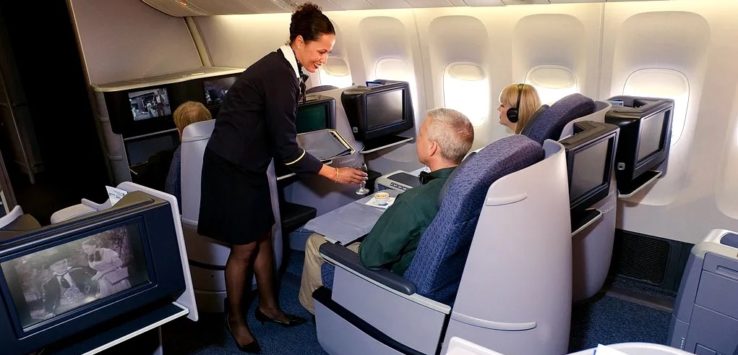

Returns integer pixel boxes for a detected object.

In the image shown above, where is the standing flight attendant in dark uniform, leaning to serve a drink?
[198,3,366,353]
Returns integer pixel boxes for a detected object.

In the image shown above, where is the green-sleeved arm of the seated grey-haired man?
[359,199,420,269]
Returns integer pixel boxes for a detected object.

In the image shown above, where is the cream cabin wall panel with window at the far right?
[601,1,738,243]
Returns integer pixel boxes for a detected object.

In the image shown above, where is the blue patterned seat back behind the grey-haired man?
[404,135,544,304]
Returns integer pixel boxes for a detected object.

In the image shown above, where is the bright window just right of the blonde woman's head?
[525,65,579,105]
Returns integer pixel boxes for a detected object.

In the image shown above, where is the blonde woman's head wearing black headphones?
[497,84,541,134]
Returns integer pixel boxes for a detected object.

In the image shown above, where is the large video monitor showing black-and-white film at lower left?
[0,191,189,354]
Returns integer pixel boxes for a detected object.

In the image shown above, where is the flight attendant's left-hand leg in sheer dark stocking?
[225,242,258,345]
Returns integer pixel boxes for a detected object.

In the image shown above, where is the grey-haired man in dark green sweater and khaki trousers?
[299,108,474,313]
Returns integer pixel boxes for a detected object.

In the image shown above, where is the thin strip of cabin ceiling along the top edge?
[142,0,660,17]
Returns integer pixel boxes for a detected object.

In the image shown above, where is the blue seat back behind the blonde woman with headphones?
[521,94,595,144]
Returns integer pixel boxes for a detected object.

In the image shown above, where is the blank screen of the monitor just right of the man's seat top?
[569,140,610,201]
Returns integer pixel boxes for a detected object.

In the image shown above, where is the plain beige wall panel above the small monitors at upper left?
[69,0,202,84]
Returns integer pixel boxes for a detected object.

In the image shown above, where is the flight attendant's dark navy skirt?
[197,149,274,244]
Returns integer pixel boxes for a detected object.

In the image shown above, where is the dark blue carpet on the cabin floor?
[155,251,671,355]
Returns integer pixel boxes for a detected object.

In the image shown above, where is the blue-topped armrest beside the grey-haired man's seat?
[320,243,415,295]
